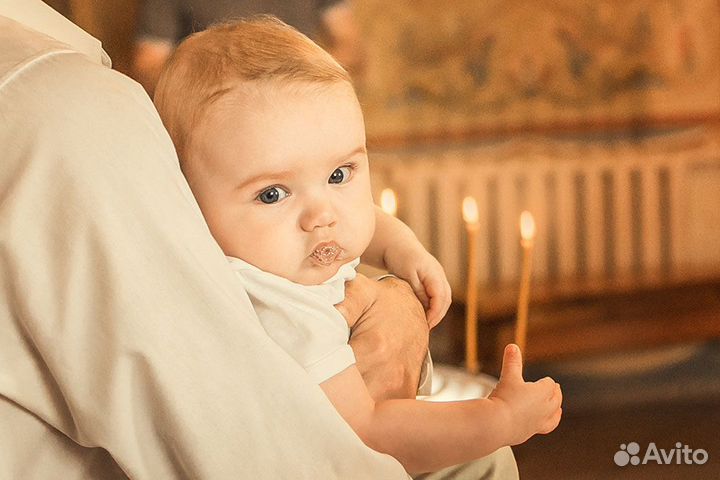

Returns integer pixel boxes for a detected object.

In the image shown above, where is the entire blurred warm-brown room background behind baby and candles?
[47,0,720,479]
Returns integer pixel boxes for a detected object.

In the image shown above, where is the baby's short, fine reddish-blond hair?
[154,15,352,166]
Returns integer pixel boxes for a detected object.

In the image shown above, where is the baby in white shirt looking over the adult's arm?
[155,17,562,473]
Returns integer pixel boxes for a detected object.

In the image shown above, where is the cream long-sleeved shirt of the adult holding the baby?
[0,0,406,480]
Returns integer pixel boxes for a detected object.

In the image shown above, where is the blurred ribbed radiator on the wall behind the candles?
[370,128,720,298]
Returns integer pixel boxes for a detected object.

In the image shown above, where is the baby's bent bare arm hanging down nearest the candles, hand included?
[361,207,451,328]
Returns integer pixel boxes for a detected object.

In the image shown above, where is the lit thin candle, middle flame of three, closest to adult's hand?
[463,197,480,374]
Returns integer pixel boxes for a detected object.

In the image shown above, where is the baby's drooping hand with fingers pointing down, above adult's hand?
[384,242,452,328]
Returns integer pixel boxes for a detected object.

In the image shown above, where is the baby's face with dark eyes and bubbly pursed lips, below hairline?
[185,83,375,285]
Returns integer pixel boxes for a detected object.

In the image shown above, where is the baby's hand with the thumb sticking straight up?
[489,345,562,445]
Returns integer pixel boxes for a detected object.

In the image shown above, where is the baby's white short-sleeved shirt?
[228,257,360,383]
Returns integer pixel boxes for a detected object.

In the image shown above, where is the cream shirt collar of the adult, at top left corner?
[0,0,111,67]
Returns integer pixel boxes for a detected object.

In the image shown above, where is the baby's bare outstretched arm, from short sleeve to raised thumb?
[321,346,562,473]
